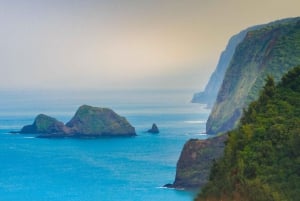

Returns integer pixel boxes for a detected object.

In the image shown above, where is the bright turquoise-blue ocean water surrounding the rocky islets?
[0,90,209,201]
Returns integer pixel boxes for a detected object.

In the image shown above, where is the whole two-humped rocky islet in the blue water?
[19,105,136,138]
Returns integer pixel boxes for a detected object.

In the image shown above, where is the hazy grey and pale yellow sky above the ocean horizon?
[0,0,300,91]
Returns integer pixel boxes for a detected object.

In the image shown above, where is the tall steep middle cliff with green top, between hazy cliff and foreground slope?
[206,17,300,134]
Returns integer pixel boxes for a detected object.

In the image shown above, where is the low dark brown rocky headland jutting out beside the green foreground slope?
[165,135,227,189]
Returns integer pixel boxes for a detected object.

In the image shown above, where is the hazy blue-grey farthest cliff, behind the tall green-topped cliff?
[192,26,260,107]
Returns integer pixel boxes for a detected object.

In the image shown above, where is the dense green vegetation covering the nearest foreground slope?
[196,66,300,201]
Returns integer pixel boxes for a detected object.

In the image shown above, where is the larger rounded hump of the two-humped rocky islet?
[66,105,136,137]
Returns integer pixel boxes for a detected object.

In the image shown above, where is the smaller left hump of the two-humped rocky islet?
[20,114,68,134]
